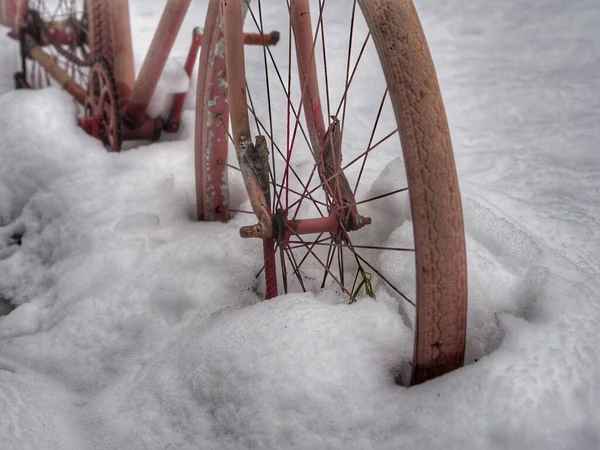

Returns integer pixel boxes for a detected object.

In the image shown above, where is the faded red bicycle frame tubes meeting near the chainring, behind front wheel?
[0,0,278,144]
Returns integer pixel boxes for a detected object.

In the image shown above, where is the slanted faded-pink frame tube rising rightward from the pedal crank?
[123,0,191,128]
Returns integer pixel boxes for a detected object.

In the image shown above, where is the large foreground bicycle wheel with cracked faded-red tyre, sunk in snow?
[196,0,467,384]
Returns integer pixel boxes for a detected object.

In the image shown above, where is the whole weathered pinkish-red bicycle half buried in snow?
[0,0,467,385]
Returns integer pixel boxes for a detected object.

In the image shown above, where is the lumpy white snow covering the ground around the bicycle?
[0,0,600,450]
